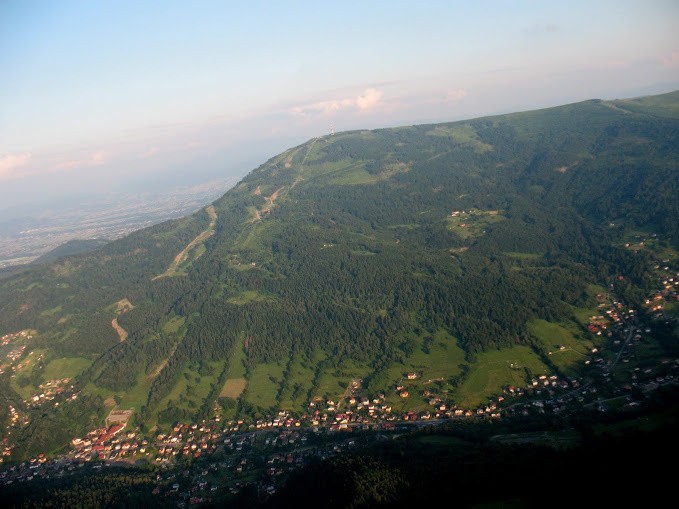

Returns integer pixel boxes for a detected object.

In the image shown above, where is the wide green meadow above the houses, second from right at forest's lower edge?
[454,346,549,408]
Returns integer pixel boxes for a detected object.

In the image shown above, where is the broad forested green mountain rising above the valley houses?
[0,92,679,456]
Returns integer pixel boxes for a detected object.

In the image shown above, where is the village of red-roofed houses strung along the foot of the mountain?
[0,254,679,507]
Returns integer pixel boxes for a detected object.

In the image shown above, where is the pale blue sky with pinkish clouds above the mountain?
[0,0,679,208]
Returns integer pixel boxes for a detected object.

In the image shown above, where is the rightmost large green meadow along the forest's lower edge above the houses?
[528,320,594,374]
